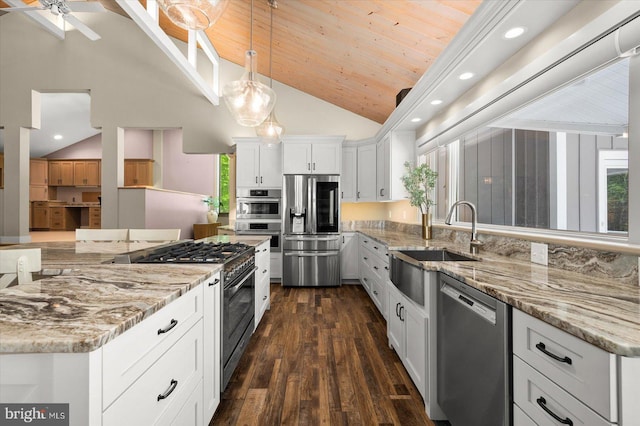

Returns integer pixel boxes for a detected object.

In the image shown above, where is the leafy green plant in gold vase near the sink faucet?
[401,161,438,240]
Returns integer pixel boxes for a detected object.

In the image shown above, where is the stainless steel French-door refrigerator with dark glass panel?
[282,175,340,287]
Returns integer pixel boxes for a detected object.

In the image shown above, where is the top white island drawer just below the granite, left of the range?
[102,286,203,407]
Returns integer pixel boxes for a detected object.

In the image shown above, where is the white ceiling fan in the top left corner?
[0,0,106,41]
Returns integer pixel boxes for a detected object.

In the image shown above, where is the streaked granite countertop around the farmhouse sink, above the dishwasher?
[356,228,640,357]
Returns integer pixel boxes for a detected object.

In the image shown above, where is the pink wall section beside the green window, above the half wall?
[162,129,217,194]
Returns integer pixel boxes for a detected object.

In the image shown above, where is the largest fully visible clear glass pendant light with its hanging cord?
[222,0,276,127]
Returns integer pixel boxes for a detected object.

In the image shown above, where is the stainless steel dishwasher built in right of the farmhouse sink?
[437,273,511,426]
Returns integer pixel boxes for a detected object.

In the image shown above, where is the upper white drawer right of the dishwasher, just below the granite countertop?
[513,309,618,422]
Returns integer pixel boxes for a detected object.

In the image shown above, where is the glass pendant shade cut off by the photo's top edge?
[158,0,229,30]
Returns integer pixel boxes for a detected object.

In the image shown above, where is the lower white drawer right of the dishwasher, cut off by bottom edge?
[513,356,611,426]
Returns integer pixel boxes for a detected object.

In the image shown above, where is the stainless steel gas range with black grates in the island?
[114,241,257,390]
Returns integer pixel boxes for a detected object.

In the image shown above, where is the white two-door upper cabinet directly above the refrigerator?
[282,136,344,175]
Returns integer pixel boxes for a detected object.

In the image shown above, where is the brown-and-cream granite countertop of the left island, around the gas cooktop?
[0,236,268,354]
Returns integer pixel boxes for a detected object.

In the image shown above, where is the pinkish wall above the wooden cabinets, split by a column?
[46,129,153,160]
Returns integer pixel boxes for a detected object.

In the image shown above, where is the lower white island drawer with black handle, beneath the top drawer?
[103,321,202,426]
